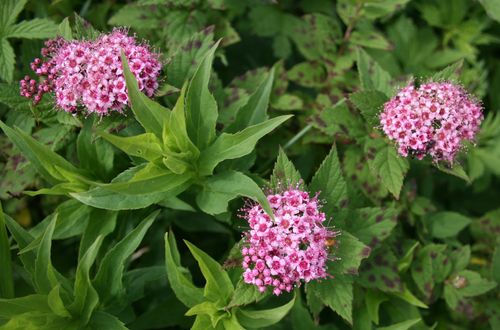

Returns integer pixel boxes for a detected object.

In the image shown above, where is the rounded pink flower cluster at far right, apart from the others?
[380,82,483,163]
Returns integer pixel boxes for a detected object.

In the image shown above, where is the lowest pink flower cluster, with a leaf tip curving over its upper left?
[241,189,337,295]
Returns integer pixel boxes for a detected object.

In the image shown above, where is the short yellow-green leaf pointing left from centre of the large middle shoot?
[98,131,163,162]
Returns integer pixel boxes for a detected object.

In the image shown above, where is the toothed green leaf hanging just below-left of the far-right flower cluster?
[365,139,409,199]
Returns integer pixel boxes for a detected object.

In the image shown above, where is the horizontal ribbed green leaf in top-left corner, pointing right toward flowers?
[5,18,57,39]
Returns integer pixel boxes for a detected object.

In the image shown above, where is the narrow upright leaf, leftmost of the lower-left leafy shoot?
[33,216,58,294]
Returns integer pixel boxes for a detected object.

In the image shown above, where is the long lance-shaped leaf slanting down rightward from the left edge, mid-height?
[0,121,84,184]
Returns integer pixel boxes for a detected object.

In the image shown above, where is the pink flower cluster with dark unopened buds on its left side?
[20,29,161,115]
